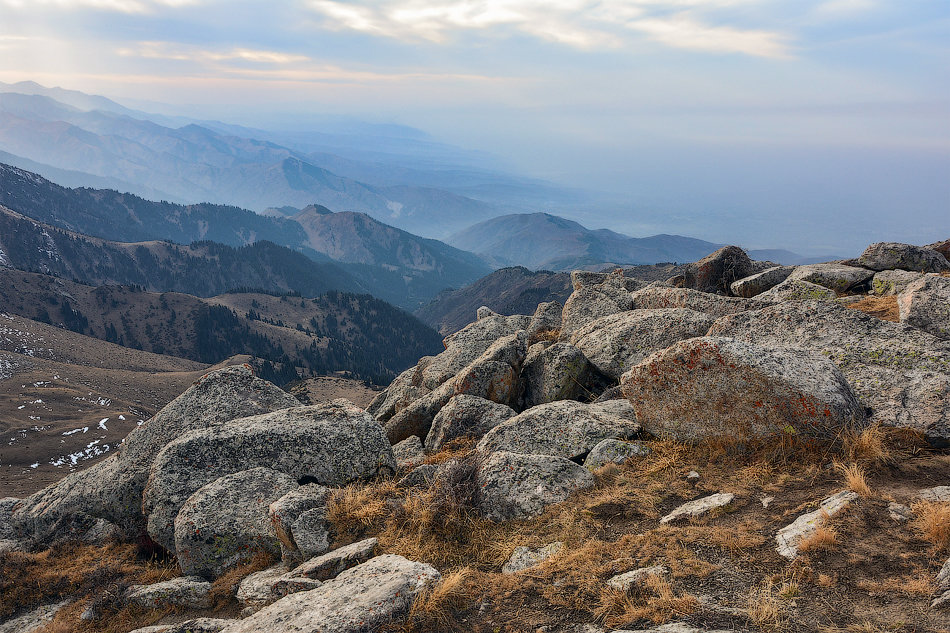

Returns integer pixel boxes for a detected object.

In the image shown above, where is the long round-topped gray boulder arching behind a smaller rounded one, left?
[143,400,396,549]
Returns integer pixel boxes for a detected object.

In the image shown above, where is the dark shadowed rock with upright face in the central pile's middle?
[521,342,606,409]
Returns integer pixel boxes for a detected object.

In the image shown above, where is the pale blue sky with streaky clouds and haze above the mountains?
[0,0,950,251]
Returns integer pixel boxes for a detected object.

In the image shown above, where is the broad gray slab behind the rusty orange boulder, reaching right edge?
[709,301,950,447]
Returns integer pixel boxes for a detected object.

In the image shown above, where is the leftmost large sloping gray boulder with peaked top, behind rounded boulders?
[13,366,300,544]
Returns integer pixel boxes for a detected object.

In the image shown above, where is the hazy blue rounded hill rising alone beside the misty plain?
[446,213,722,270]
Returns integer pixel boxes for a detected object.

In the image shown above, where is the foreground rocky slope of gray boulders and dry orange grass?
[0,238,950,633]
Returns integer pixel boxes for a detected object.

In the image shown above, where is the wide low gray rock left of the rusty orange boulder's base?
[477,400,640,459]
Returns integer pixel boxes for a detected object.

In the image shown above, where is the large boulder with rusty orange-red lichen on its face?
[621,337,864,442]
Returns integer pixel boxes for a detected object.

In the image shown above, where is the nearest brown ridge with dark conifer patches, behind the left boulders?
[0,268,442,383]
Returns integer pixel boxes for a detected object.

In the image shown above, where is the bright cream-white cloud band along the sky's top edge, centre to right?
[307,0,796,57]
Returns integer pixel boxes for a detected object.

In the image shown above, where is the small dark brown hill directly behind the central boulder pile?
[415,266,571,335]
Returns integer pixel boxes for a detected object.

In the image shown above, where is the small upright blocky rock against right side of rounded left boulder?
[267,484,330,564]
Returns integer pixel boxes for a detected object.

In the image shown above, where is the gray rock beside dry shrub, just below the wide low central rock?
[478,451,594,521]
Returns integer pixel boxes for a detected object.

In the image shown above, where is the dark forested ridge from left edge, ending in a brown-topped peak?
[0,164,491,309]
